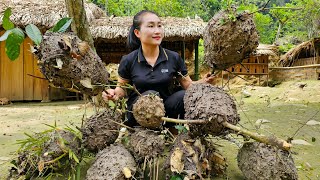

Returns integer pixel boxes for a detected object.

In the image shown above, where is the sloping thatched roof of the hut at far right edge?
[279,38,320,67]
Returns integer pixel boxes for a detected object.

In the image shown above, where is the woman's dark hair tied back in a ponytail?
[127,10,158,51]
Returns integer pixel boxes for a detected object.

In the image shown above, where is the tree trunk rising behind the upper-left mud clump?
[65,0,95,49]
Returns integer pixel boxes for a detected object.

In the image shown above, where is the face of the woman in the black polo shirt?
[134,13,164,46]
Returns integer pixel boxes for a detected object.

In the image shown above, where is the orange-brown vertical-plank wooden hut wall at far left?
[0,32,66,101]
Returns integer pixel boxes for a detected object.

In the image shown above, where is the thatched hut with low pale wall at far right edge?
[270,38,320,81]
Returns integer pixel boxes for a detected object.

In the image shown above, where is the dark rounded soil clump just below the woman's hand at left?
[81,109,122,152]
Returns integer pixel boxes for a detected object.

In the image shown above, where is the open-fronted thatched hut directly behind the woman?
[90,17,206,78]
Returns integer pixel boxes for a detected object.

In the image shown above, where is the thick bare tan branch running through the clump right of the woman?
[161,117,292,151]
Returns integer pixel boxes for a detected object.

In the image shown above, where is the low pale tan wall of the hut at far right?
[269,64,320,81]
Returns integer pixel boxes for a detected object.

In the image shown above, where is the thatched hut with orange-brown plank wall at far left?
[0,0,104,101]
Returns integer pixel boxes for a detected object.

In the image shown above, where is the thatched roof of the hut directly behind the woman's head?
[90,17,206,41]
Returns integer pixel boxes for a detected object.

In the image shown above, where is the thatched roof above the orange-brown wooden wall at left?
[0,0,105,29]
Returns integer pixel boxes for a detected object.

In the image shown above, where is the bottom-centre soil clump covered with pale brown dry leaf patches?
[164,134,227,179]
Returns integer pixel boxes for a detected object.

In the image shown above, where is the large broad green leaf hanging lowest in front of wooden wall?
[5,28,24,61]
